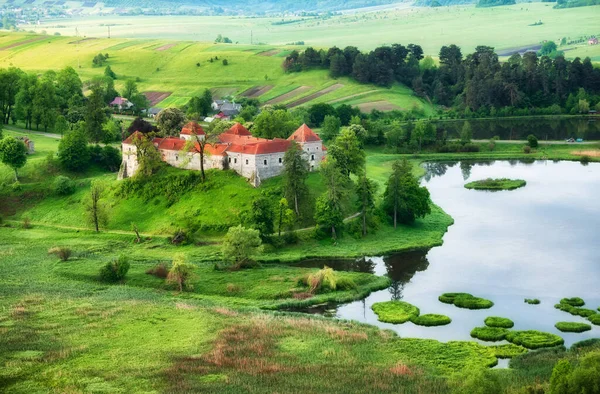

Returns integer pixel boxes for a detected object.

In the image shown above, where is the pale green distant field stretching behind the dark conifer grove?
[25,2,600,57]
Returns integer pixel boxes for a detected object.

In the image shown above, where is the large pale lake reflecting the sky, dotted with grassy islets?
[294,161,600,346]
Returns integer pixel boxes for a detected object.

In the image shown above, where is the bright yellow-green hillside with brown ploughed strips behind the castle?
[0,33,433,114]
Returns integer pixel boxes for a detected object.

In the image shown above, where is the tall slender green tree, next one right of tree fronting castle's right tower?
[315,158,350,239]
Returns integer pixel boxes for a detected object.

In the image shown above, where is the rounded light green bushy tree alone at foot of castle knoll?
[221,225,262,266]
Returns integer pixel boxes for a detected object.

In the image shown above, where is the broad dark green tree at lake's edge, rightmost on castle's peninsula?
[383,159,431,228]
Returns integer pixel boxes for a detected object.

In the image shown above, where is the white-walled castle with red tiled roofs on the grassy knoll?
[119,122,327,187]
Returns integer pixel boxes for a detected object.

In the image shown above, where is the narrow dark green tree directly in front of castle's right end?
[283,142,308,216]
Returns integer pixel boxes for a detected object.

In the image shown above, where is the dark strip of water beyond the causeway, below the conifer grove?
[436,117,600,141]
